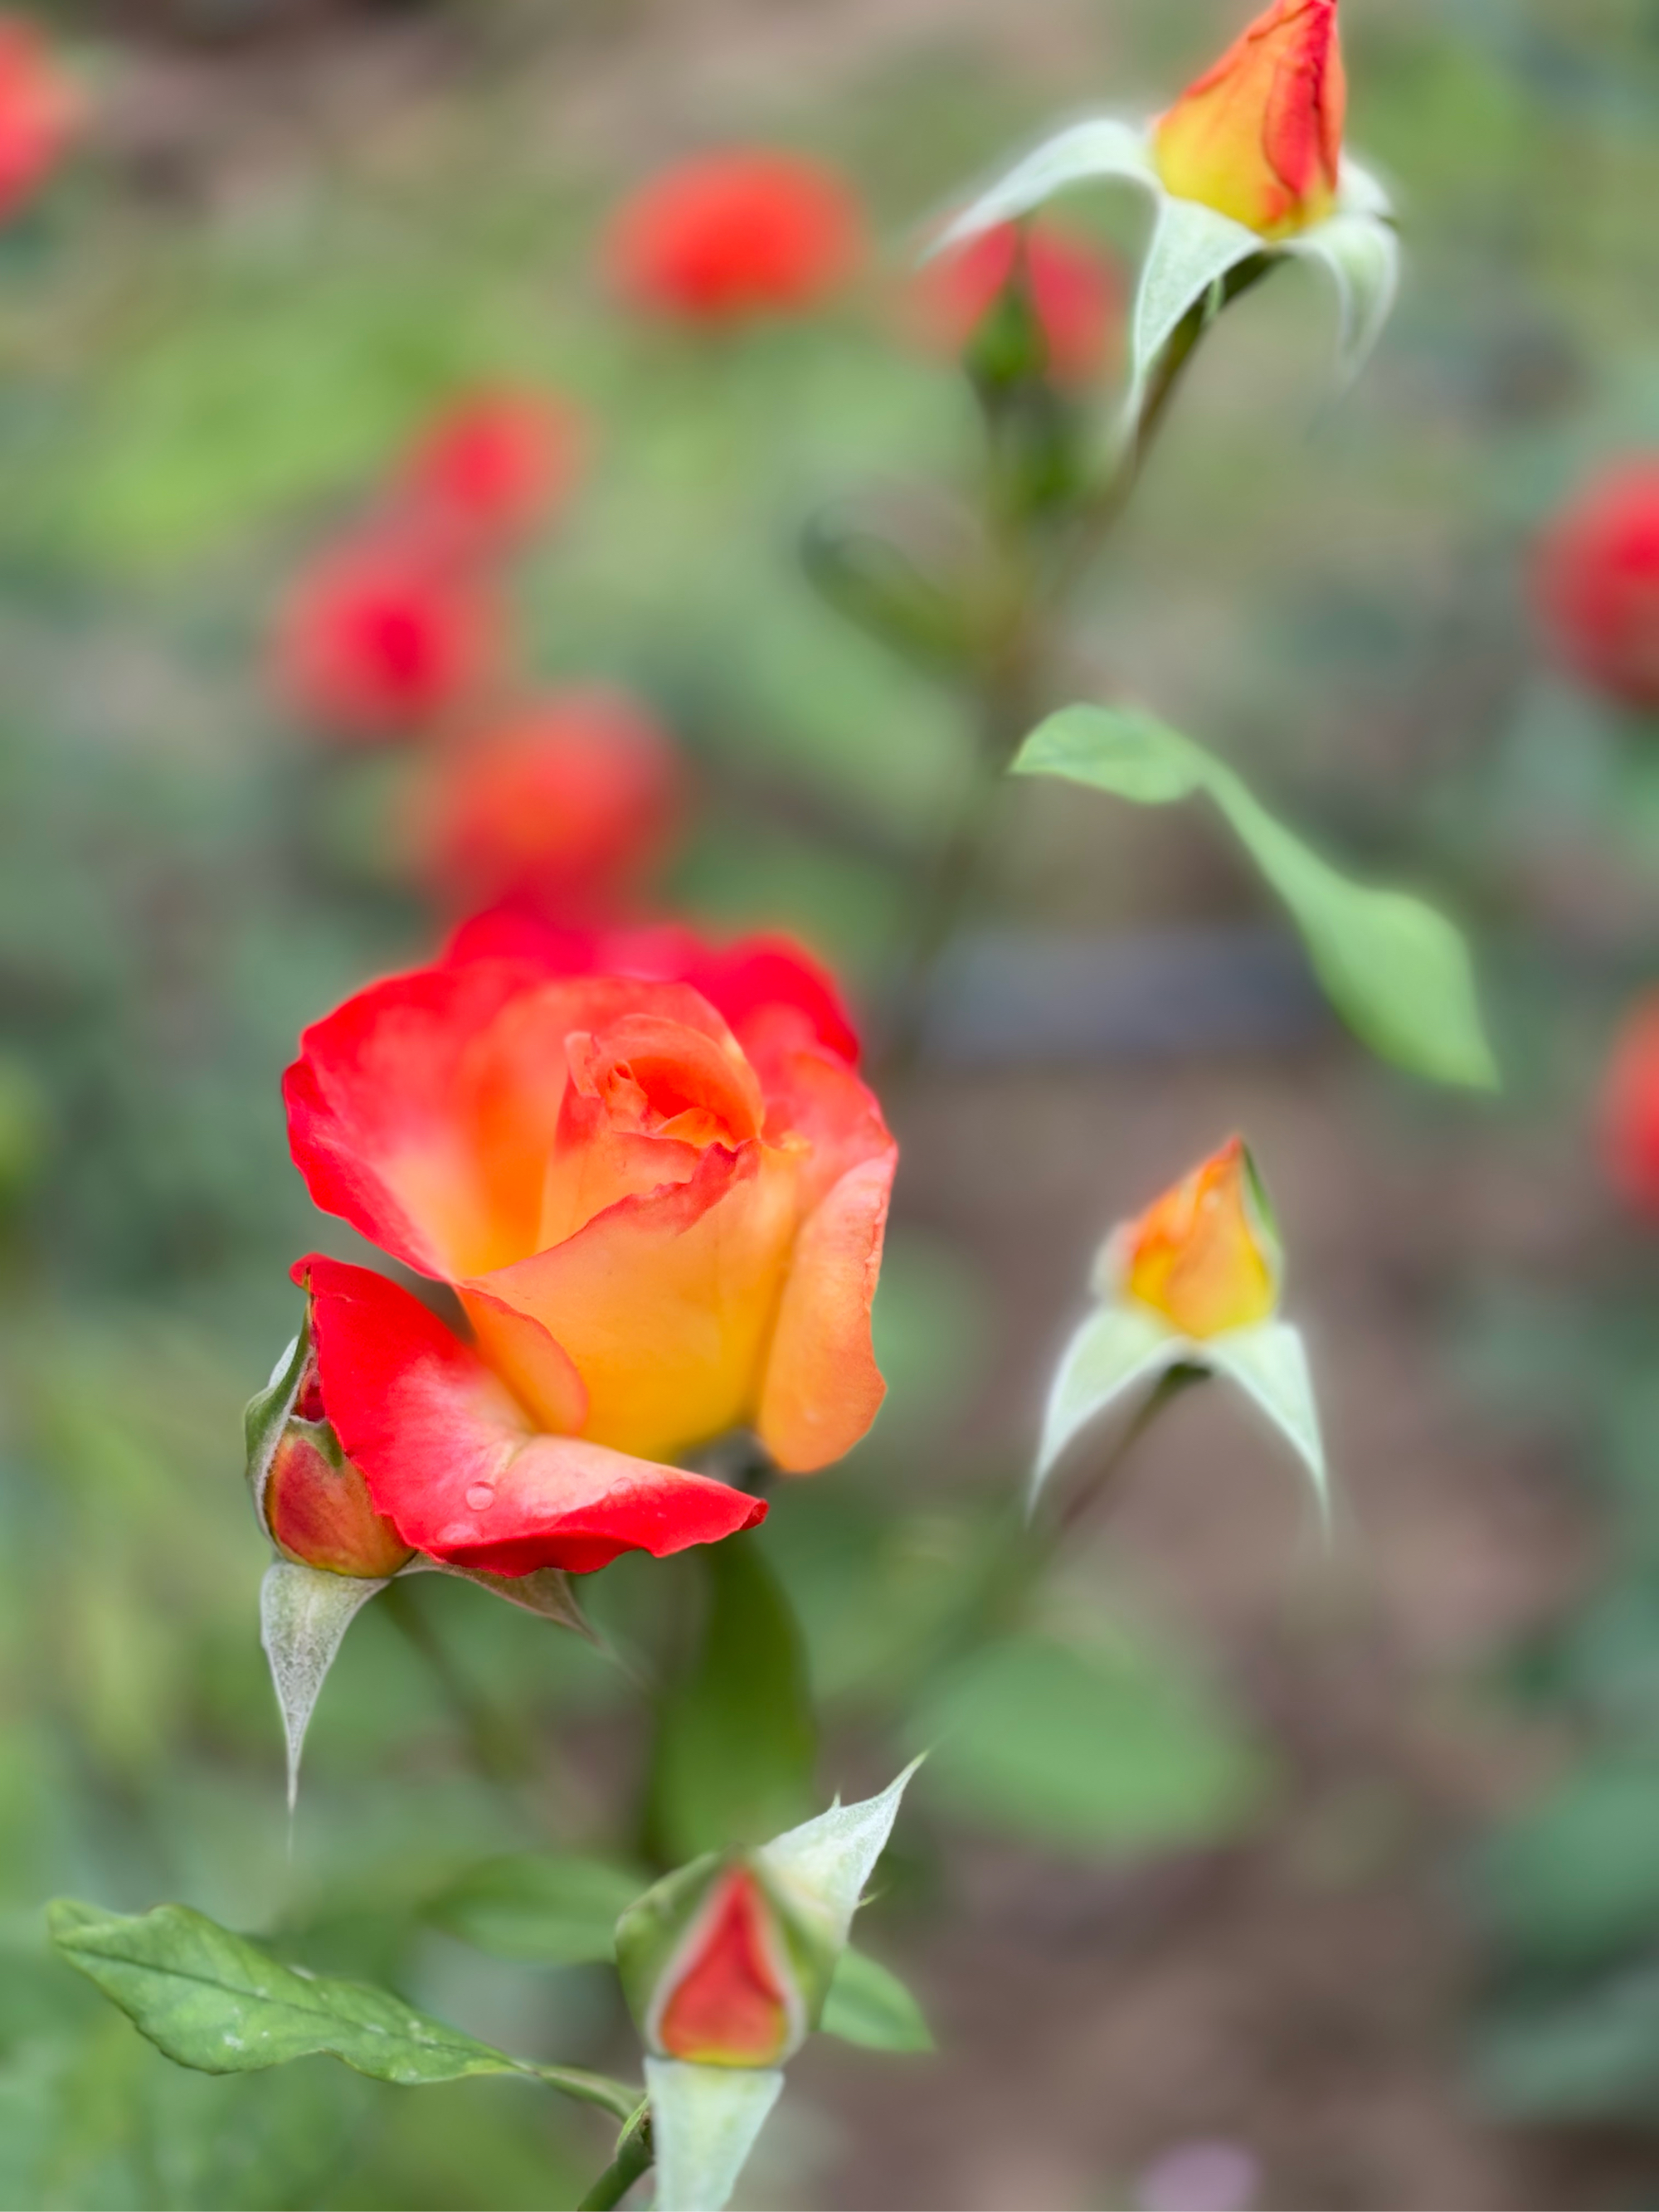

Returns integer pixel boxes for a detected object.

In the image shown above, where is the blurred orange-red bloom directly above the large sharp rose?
[409,686,686,920]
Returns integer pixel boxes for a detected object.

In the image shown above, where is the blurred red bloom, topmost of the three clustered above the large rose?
[402,389,581,553]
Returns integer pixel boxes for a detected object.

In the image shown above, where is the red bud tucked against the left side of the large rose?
[246,1327,414,1582]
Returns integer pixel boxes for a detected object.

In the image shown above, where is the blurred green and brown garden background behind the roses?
[0,0,1659,2212]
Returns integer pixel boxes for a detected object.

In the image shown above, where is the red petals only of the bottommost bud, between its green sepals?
[654,1864,800,2066]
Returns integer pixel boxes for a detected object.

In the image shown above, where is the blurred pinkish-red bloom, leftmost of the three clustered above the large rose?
[276,531,502,743]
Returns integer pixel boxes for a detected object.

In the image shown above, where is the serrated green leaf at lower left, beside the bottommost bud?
[46,1898,637,2119]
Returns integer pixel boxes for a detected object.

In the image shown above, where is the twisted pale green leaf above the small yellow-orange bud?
[1013,706,1497,1091]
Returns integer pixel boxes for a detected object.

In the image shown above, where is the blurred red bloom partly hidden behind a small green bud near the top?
[916,223,1124,385]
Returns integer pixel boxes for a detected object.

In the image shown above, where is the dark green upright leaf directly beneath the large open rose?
[648,1535,819,1864]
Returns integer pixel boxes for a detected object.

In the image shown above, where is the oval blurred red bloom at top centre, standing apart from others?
[604,148,865,323]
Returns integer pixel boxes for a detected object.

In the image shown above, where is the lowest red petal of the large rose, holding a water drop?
[294,1254,766,1575]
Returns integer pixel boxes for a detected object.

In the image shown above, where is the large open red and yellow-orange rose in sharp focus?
[283,926,896,1575]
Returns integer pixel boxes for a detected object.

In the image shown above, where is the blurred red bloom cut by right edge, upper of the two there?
[1533,455,1659,710]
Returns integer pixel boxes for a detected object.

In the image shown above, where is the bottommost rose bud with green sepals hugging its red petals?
[617,1858,818,2066]
